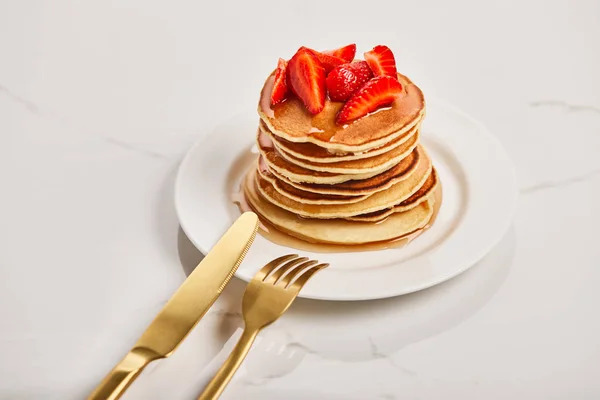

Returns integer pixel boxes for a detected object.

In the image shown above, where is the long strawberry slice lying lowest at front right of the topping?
[336,76,402,124]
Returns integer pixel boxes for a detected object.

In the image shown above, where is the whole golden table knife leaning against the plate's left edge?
[88,212,258,400]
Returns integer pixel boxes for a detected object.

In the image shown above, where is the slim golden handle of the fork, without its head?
[198,326,260,400]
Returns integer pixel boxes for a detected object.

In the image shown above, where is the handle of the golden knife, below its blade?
[88,347,163,400]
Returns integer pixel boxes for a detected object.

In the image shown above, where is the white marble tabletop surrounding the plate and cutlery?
[0,0,600,400]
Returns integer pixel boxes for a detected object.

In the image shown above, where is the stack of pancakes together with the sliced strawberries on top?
[237,45,441,252]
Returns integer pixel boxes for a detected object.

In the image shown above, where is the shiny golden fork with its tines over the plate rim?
[198,254,329,400]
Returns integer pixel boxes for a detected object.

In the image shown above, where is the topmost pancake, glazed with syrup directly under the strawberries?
[258,74,425,153]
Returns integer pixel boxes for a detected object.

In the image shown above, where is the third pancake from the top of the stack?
[257,131,419,184]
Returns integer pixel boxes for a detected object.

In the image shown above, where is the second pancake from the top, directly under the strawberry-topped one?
[259,120,420,163]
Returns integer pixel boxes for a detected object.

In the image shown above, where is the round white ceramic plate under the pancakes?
[175,99,517,300]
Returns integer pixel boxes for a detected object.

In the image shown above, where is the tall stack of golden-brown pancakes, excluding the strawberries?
[243,75,440,245]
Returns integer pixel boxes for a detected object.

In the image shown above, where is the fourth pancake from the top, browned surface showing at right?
[270,146,421,196]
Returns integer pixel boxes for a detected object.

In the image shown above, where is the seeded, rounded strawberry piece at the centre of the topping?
[327,61,373,101]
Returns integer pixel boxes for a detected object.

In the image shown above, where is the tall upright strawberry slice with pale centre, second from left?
[287,47,325,114]
